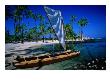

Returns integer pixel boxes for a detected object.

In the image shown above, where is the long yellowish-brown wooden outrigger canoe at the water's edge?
[13,50,80,68]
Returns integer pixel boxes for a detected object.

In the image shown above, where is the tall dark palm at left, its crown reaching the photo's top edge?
[14,5,29,43]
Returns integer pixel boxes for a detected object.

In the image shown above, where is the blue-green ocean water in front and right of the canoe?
[39,41,106,70]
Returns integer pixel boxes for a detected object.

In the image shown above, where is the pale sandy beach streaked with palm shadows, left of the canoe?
[5,40,59,69]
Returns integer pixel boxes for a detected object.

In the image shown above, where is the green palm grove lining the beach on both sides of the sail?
[5,5,88,43]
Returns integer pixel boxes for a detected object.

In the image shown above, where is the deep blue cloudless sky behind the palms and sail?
[5,5,106,38]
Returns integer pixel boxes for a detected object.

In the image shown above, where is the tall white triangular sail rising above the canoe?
[44,6,66,50]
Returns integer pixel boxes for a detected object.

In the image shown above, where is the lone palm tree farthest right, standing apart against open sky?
[78,18,88,40]
